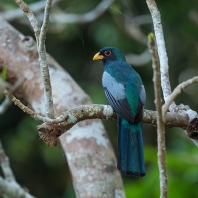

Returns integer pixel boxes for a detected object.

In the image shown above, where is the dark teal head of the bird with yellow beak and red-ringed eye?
[93,47,126,62]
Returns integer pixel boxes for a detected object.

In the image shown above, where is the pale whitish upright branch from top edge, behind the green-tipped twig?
[146,0,175,108]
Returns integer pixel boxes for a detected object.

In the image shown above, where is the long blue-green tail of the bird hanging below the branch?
[117,116,145,177]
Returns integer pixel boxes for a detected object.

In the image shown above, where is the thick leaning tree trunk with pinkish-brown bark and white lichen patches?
[0,18,125,198]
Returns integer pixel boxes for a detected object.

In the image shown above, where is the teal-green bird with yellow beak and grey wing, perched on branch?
[93,47,146,177]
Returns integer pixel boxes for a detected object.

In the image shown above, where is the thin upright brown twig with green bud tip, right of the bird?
[148,33,168,198]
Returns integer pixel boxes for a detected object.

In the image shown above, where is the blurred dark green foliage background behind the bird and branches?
[0,0,198,198]
